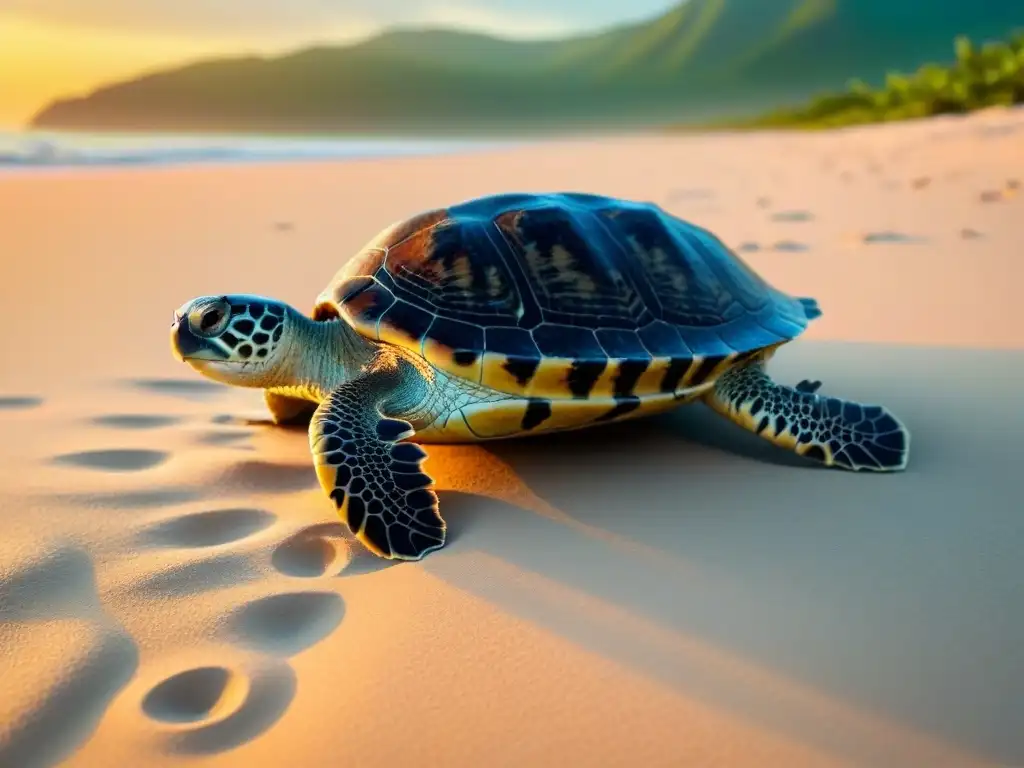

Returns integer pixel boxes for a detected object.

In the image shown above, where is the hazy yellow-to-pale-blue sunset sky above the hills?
[0,0,678,128]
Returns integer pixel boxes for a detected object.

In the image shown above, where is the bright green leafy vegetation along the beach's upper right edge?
[744,32,1024,128]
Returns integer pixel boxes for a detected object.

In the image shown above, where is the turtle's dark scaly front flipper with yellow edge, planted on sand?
[309,360,445,560]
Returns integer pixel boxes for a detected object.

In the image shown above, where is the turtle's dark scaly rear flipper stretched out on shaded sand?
[705,362,910,472]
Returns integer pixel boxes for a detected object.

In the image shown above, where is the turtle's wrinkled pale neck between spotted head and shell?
[264,310,377,402]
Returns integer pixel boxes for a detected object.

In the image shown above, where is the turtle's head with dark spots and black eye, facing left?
[171,295,298,387]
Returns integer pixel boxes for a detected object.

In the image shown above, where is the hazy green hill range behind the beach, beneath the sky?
[32,0,1024,133]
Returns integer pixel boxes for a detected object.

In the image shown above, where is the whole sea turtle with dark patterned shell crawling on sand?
[171,193,909,560]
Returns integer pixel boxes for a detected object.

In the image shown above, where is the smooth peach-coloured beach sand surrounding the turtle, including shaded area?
[0,111,1024,768]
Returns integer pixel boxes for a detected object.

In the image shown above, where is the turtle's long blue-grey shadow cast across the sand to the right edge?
[423,344,1022,765]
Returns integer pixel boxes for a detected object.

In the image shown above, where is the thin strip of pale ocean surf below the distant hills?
[0,131,516,170]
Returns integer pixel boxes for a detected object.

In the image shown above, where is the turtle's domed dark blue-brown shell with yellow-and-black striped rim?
[313,194,817,399]
